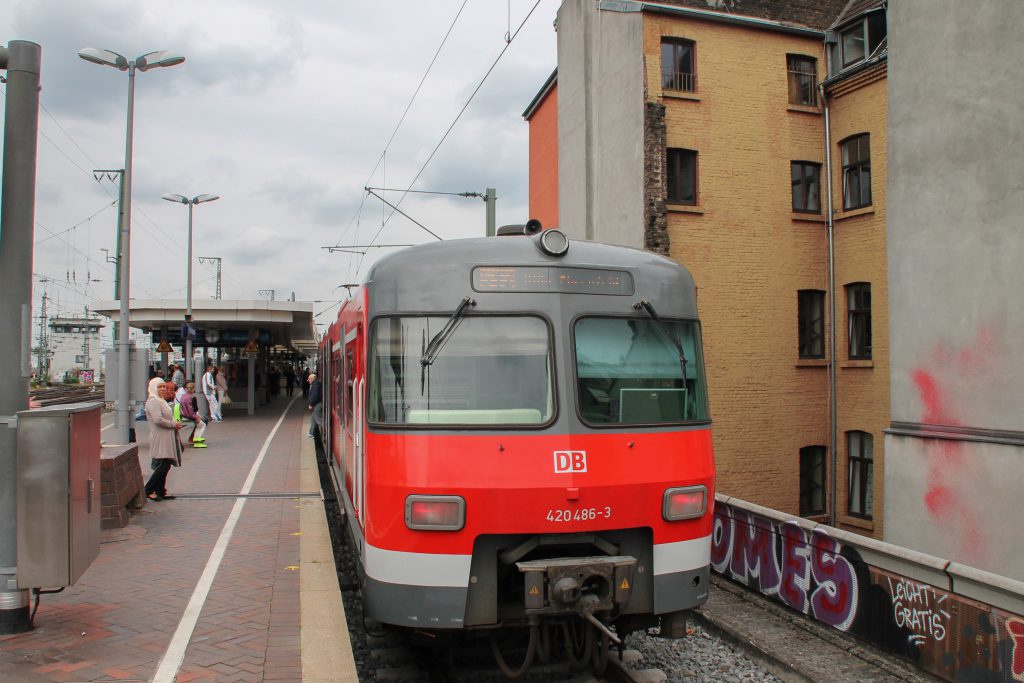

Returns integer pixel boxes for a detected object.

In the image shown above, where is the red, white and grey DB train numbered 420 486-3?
[318,221,715,666]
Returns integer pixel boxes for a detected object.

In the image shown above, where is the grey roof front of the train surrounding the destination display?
[366,236,696,317]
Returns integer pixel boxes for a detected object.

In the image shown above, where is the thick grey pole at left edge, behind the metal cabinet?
[0,40,42,635]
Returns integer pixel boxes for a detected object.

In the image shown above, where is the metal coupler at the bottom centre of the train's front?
[515,555,637,614]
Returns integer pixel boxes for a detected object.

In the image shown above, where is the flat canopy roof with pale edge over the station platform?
[92,299,317,356]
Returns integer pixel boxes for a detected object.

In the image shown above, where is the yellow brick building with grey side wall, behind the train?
[544,0,890,538]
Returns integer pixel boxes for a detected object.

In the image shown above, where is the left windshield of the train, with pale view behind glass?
[368,315,555,426]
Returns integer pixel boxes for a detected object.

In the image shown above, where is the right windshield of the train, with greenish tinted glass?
[574,317,710,426]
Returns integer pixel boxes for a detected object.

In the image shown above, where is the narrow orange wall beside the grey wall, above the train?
[528,85,558,227]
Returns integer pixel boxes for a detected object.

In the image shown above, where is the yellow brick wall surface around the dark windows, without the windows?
[644,13,888,536]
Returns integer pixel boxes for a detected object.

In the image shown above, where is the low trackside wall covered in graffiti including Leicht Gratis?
[712,502,1024,683]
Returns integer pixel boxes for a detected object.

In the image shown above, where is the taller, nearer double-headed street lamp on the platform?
[78,47,185,443]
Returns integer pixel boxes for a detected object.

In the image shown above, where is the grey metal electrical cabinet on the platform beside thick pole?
[17,402,103,589]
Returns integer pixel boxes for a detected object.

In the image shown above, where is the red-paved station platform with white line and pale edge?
[0,394,357,683]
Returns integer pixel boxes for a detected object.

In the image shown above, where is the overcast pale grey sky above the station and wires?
[0,0,558,339]
